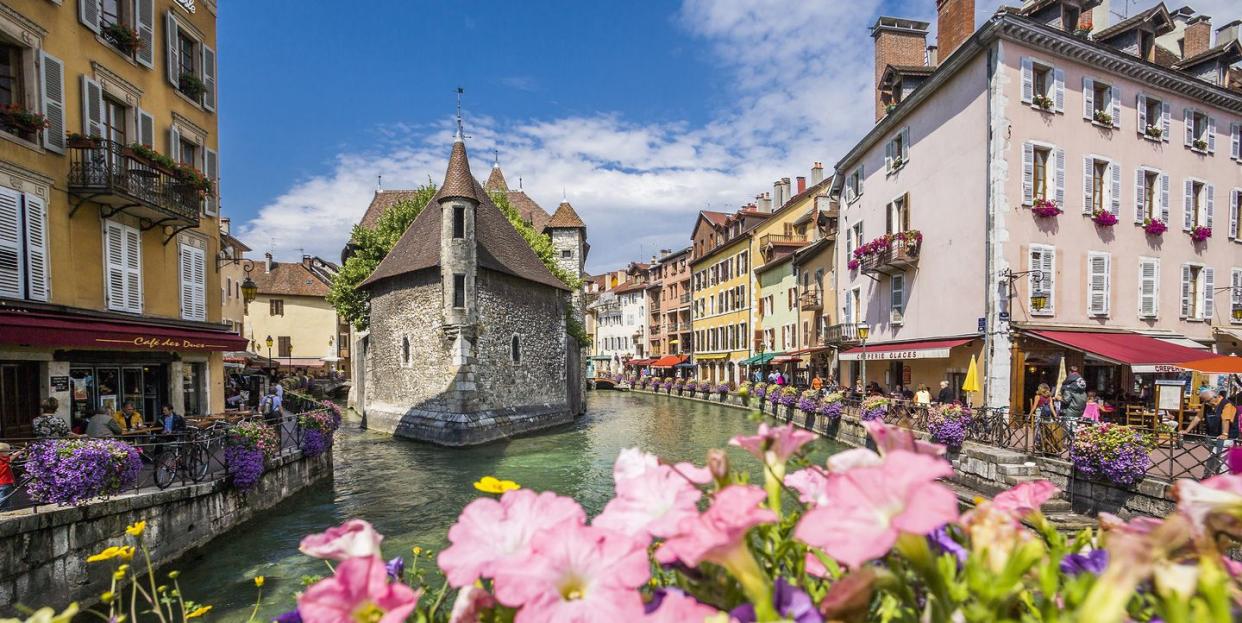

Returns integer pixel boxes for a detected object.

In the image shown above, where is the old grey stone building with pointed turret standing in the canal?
[359,132,585,446]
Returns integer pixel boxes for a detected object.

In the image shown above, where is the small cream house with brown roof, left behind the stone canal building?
[245,254,349,374]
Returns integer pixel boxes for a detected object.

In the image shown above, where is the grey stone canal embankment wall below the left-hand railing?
[0,452,332,616]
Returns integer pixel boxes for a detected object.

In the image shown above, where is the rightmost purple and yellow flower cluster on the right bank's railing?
[1069,423,1155,485]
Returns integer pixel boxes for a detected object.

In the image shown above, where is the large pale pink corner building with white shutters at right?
[835,0,1242,408]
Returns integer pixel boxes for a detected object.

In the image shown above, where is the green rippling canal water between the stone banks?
[175,391,836,622]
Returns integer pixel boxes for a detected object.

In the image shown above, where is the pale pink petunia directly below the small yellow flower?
[437,489,586,588]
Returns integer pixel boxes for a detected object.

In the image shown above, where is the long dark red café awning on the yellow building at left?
[0,312,250,351]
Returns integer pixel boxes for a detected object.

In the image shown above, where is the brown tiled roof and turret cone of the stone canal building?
[359,141,569,290]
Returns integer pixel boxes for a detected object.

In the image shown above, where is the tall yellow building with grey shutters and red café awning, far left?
[0,0,243,436]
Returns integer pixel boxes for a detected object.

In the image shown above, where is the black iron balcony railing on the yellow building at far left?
[68,139,202,226]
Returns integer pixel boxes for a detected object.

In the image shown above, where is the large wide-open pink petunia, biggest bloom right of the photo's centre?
[794,450,958,568]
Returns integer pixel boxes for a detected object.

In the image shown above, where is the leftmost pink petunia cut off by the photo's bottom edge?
[298,556,419,623]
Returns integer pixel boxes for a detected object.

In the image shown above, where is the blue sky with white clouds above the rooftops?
[217,0,1238,273]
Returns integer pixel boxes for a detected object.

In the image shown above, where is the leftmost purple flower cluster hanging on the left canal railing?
[26,438,143,506]
